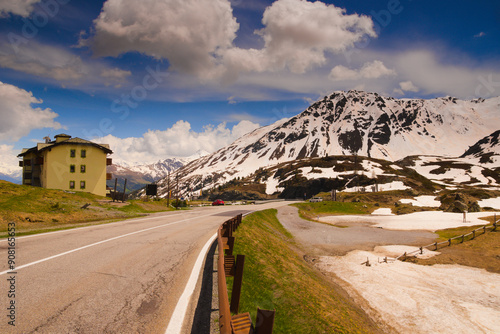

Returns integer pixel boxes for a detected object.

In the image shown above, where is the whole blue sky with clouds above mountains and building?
[0,0,500,173]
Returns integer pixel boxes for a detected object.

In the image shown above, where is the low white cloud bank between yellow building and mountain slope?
[98,120,259,163]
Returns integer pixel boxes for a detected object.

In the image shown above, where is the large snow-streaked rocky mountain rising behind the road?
[154,91,500,197]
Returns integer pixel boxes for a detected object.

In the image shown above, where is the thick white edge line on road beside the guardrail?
[165,233,217,334]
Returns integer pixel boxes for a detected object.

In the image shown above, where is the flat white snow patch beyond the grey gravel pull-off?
[319,211,500,232]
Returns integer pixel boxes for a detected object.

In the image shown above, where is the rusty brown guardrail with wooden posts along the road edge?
[217,214,275,334]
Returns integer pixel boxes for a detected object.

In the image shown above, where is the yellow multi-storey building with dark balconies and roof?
[18,134,113,196]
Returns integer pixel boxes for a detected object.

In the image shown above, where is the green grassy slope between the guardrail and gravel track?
[228,209,380,334]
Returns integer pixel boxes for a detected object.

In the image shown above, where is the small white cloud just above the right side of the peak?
[329,60,396,81]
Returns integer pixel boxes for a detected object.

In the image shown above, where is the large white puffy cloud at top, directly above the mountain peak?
[223,0,376,76]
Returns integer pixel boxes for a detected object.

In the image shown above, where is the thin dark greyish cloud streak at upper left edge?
[0,40,131,85]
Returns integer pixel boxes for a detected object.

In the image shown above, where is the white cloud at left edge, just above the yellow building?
[0,82,61,141]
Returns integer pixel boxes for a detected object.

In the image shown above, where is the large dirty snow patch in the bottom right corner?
[316,247,500,334]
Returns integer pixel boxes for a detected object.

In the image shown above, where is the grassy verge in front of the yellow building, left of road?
[0,180,174,237]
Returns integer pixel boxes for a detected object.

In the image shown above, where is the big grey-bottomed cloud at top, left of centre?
[85,0,239,77]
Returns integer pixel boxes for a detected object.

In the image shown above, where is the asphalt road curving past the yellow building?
[0,202,287,333]
